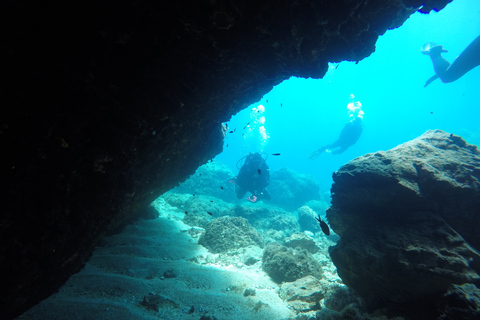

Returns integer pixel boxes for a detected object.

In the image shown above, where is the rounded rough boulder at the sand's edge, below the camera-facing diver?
[198,217,263,253]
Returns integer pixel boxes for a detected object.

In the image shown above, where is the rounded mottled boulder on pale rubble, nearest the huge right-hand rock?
[262,242,323,283]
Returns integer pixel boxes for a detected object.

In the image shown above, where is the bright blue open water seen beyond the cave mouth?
[216,0,480,191]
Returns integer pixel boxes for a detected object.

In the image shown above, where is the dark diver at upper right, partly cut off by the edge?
[421,36,480,87]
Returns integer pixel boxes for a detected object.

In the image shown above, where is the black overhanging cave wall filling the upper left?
[0,0,450,318]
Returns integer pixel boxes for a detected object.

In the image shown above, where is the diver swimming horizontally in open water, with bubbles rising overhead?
[310,94,365,160]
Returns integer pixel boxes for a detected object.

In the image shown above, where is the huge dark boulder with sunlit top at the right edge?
[327,130,480,319]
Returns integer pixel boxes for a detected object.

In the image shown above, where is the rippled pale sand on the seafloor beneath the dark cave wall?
[18,199,339,320]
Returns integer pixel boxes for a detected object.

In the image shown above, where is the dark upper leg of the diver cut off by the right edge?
[439,36,480,83]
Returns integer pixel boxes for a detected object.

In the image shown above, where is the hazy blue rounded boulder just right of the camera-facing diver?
[268,168,320,210]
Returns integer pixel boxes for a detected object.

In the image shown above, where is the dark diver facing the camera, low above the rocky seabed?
[234,152,270,202]
